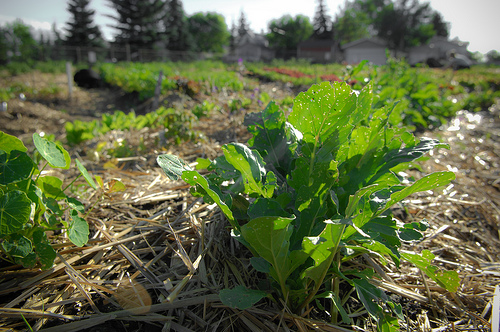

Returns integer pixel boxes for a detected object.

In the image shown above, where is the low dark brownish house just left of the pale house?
[297,39,342,63]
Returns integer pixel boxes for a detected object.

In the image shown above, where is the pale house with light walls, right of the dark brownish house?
[342,38,387,65]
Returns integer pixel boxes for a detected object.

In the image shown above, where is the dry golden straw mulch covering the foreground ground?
[0,92,500,332]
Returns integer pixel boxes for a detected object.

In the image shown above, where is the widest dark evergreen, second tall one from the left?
[107,0,166,48]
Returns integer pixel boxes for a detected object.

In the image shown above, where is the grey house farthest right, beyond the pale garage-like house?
[408,36,470,65]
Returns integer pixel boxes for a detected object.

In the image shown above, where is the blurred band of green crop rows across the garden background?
[0,59,500,134]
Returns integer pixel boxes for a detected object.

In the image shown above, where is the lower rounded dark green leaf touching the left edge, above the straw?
[0,190,31,235]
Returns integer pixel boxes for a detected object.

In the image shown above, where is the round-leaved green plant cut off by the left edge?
[0,132,97,269]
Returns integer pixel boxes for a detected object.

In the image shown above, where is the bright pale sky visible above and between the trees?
[0,0,500,54]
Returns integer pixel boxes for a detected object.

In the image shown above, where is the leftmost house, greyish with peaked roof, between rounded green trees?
[226,31,274,61]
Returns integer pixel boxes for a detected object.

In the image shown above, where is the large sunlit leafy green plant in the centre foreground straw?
[157,82,459,331]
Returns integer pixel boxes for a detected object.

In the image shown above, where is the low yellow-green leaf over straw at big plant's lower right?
[401,250,460,292]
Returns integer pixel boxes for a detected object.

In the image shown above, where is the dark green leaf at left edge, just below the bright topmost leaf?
[0,150,35,185]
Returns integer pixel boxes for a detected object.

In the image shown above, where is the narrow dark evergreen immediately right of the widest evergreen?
[164,0,194,51]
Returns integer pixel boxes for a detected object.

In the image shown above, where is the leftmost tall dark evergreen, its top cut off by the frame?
[64,0,103,46]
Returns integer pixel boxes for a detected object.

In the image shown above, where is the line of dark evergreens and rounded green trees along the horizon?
[0,0,496,63]
